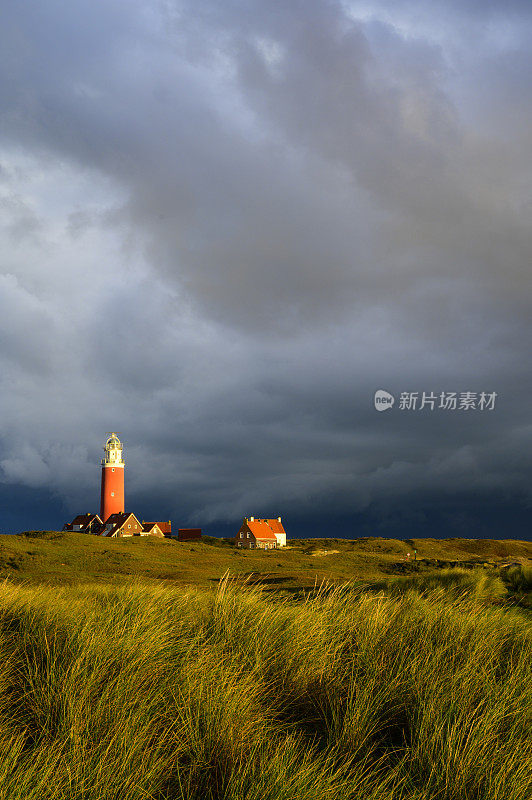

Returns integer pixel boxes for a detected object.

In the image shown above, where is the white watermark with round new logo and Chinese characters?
[373,389,498,411]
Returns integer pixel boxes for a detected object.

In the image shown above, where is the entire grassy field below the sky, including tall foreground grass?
[0,532,532,800]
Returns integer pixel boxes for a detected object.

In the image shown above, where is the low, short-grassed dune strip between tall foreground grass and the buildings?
[0,531,532,593]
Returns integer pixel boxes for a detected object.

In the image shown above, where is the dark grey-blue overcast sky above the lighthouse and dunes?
[0,0,532,539]
